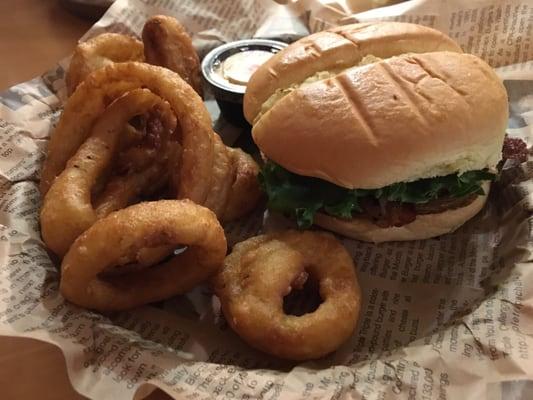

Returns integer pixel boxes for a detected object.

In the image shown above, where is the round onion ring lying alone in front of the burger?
[213,231,361,360]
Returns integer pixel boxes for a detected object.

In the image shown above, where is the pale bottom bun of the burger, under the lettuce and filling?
[315,183,490,243]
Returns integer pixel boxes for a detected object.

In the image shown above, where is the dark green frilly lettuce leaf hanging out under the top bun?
[259,161,495,228]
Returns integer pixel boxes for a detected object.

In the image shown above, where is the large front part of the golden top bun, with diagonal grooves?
[252,52,508,189]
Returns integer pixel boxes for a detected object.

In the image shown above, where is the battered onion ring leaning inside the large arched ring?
[41,89,172,256]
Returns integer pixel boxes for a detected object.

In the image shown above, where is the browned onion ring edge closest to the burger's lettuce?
[222,147,262,222]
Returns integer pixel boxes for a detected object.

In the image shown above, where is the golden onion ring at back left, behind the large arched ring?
[65,33,144,96]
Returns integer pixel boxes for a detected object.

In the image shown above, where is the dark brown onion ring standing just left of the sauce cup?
[142,15,203,96]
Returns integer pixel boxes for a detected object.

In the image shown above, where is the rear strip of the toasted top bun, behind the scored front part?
[243,22,462,123]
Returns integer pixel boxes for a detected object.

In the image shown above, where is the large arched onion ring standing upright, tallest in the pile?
[40,62,214,204]
